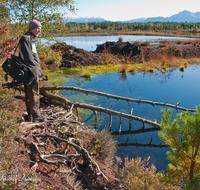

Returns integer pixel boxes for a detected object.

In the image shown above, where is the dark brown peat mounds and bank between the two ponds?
[46,41,200,68]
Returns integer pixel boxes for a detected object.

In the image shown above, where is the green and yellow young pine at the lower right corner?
[159,106,200,186]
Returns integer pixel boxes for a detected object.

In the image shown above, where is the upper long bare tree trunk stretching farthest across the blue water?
[41,86,196,112]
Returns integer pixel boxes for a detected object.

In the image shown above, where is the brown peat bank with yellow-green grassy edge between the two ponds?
[42,40,200,76]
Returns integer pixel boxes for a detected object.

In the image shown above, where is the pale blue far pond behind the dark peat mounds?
[53,35,194,51]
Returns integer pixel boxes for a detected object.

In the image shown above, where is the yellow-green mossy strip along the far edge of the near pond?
[45,57,200,79]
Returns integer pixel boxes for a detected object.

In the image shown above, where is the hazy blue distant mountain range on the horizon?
[65,10,200,23]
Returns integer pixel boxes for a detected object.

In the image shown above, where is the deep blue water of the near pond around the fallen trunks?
[50,65,200,171]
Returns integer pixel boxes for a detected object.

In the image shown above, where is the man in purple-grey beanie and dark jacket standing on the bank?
[19,19,44,122]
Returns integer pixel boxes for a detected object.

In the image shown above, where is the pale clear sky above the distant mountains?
[66,0,200,21]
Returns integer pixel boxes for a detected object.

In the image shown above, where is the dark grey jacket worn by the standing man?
[19,31,41,77]
